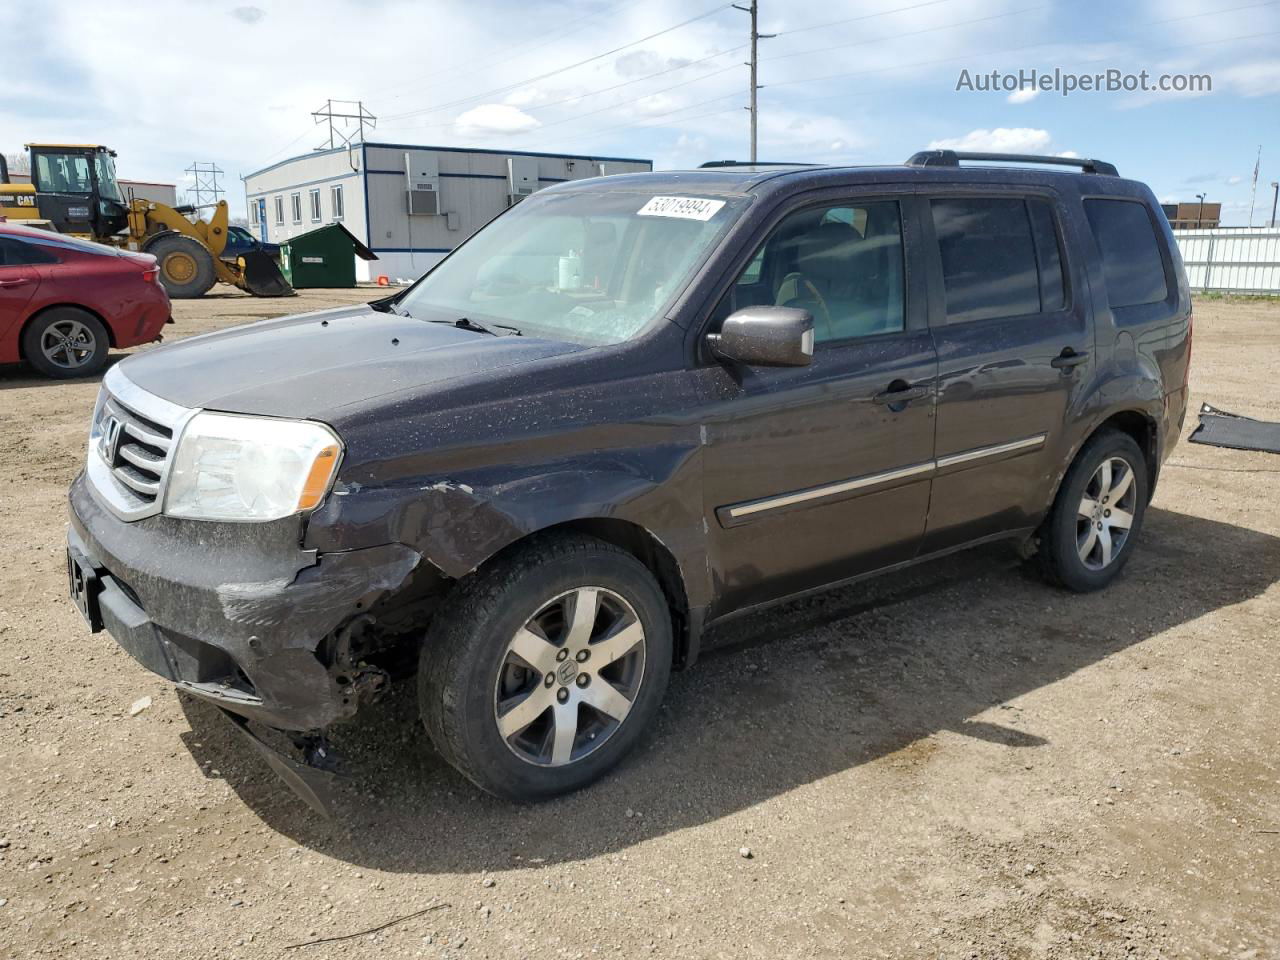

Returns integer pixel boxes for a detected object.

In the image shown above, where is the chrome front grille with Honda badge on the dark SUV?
[88,367,196,520]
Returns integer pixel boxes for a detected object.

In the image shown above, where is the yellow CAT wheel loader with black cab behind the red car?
[0,143,293,300]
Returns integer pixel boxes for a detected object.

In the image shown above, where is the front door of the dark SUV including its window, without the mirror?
[704,198,937,616]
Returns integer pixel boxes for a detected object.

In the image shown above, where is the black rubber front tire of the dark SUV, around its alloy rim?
[417,535,672,801]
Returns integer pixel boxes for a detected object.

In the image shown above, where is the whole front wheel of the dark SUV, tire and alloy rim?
[419,536,672,800]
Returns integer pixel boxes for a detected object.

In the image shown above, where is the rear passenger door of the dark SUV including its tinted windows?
[922,189,1093,553]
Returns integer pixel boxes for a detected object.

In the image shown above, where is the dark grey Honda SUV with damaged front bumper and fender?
[68,151,1192,814]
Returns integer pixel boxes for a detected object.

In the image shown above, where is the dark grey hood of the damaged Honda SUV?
[120,305,582,420]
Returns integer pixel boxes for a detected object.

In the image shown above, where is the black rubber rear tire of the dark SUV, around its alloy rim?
[1038,429,1148,593]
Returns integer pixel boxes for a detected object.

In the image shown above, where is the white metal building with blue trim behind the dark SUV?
[243,143,653,283]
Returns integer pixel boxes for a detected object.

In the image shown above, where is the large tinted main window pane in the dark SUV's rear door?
[932,197,1044,323]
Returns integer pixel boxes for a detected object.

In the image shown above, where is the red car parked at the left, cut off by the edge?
[0,220,169,379]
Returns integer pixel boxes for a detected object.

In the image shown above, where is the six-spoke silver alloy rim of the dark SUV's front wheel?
[494,586,645,767]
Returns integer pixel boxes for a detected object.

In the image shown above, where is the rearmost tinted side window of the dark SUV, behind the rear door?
[1084,200,1169,307]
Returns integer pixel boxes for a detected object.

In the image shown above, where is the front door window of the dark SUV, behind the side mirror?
[718,200,905,343]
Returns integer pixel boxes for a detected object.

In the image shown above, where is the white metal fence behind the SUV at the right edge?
[1174,227,1280,294]
